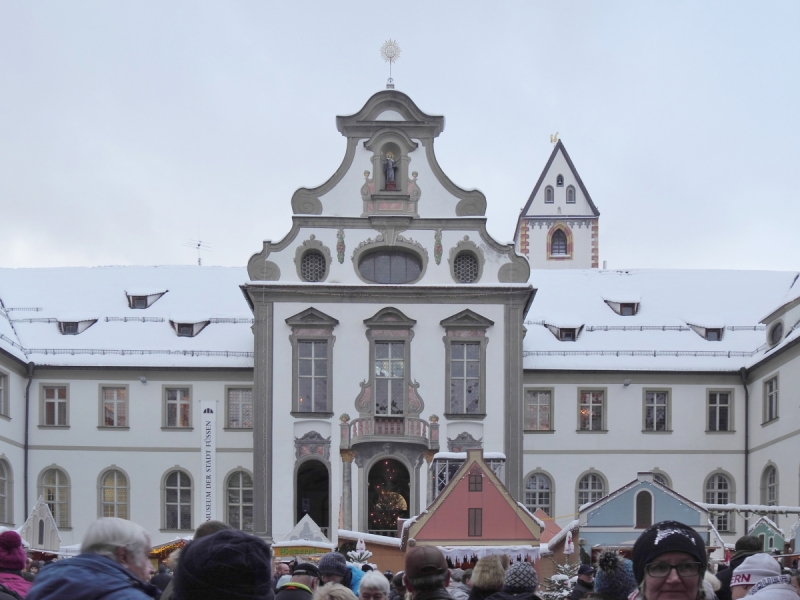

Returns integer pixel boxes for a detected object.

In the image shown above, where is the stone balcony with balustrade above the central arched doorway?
[340,416,439,450]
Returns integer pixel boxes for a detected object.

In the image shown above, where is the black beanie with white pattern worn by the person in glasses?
[633,521,708,583]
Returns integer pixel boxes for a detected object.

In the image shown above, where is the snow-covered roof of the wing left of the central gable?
[0,266,253,368]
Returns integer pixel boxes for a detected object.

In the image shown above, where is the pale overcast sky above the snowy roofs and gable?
[0,0,800,270]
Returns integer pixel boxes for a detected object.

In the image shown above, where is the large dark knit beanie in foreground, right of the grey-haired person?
[174,529,273,600]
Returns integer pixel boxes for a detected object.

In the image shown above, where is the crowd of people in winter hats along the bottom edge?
[0,518,800,600]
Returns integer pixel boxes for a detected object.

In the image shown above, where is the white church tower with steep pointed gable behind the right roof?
[514,140,600,269]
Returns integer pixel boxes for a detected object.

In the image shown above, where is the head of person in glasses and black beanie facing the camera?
[633,521,708,600]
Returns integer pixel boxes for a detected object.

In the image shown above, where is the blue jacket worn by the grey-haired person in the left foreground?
[26,554,158,600]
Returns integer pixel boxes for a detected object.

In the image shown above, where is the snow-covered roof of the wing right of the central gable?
[524,269,800,371]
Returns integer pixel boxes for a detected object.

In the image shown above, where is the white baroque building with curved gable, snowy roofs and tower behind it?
[0,90,800,545]
